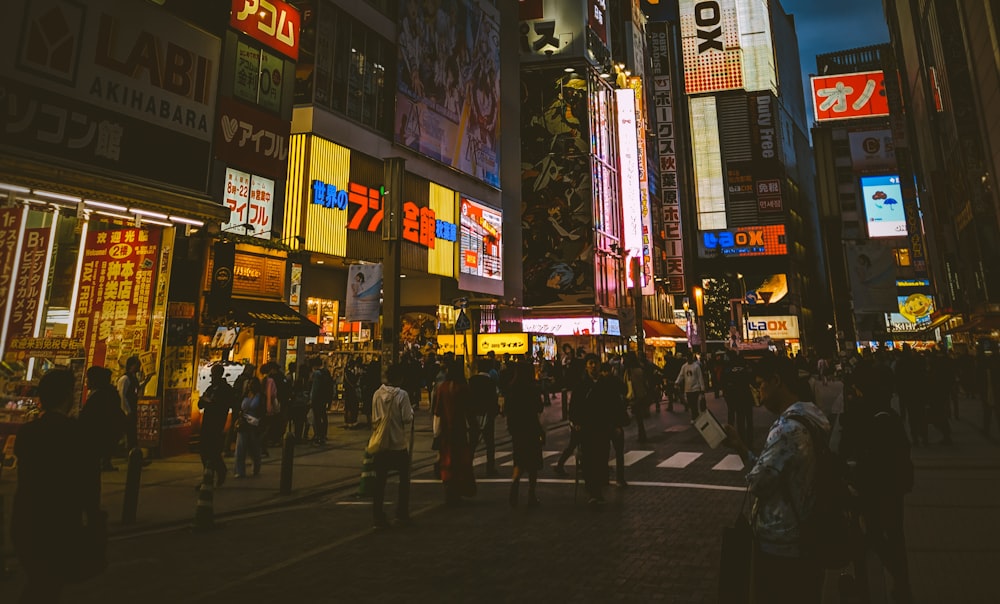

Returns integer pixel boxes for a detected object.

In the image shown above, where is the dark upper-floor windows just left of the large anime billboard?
[306,3,396,136]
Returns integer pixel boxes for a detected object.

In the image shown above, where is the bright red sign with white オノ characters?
[812,71,889,122]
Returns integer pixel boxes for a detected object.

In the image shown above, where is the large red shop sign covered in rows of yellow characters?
[73,229,160,371]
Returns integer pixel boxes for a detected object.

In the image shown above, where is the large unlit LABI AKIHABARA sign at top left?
[0,0,221,141]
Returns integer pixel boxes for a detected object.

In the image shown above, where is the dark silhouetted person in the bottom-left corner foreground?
[10,369,106,604]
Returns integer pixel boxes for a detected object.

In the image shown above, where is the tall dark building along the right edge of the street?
[883,0,1000,346]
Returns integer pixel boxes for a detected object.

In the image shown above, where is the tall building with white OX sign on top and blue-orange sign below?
[679,0,825,350]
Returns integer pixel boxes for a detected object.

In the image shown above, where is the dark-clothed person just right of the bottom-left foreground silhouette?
[80,366,128,472]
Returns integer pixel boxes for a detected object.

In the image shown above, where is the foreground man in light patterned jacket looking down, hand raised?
[725,356,830,604]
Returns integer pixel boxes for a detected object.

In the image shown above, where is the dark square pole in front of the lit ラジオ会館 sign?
[382,157,406,383]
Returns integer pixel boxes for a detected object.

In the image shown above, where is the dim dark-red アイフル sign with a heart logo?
[215,97,292,179]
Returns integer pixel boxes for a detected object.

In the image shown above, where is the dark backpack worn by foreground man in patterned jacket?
[786,414,856,569]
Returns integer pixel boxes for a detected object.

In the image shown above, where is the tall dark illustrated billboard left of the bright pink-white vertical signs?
[521,71,594,306]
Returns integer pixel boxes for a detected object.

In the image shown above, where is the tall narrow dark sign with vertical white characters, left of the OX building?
[647,23,687,294]
